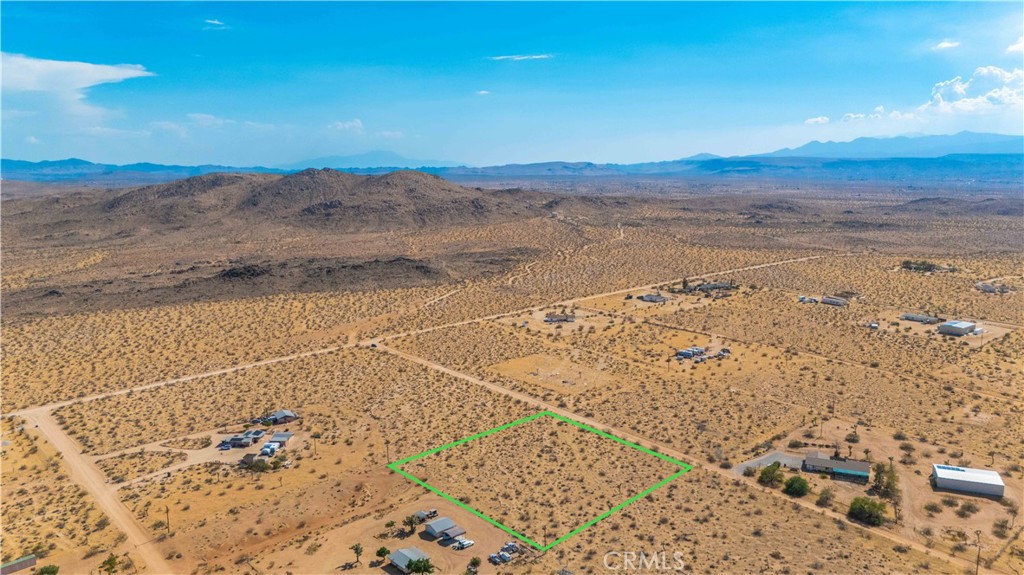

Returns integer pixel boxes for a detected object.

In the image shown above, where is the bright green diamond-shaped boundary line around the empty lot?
[387,410,693,551]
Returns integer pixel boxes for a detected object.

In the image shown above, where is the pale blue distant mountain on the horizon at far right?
[759,132,1024,159]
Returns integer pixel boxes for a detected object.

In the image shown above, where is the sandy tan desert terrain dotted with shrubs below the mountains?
[0,170,1024,575]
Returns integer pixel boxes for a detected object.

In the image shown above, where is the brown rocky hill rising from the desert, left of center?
[80,169,551,231]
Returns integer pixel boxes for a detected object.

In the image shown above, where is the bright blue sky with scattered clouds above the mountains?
[0,2,1024,166]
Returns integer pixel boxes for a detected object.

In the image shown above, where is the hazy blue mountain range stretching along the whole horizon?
[0,132,1024,187]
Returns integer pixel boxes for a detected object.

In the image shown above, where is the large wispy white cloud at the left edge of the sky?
[0,52,155,116]
